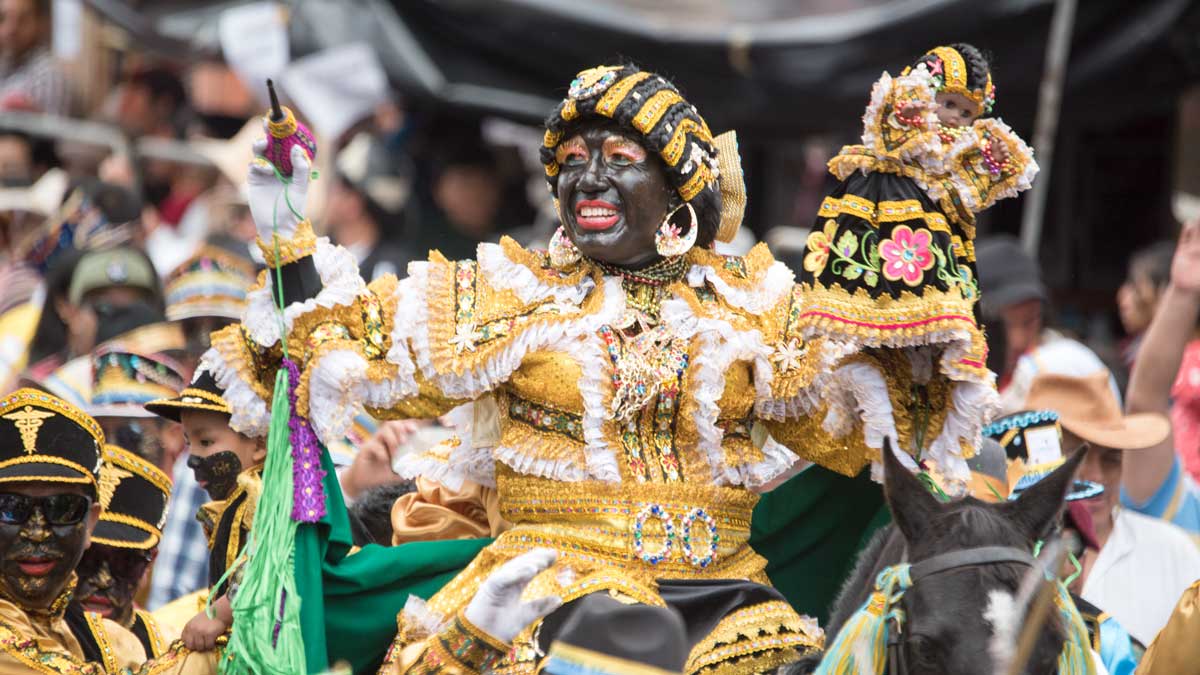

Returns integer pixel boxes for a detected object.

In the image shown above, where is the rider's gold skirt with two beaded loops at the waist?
[396,468,823,675]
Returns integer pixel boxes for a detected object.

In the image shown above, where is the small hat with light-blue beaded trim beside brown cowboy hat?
[983,410,1104,501]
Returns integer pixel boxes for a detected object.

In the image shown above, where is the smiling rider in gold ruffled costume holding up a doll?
[202,59,1032,673]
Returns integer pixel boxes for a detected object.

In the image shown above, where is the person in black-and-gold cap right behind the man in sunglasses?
[74,446,178,657]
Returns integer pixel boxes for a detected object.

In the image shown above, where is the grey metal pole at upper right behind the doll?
[1021,0,1075,257]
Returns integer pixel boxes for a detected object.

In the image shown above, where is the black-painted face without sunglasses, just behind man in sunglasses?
[74,544,154,627]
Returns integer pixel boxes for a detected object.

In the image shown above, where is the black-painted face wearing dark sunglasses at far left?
[0,503,88,610]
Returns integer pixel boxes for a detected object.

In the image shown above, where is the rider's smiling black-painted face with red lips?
[556,125,672,268]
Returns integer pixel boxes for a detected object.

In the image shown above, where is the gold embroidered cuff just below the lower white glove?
[379,613,509,675]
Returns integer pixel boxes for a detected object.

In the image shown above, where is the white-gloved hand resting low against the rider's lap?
[463,549,563,644]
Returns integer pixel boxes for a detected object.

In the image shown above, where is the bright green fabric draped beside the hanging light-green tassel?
[295,447,492,674]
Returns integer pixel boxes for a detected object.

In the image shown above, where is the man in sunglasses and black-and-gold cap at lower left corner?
[0,389,145,673]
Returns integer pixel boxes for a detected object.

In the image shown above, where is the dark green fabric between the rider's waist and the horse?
[750,466,892,626]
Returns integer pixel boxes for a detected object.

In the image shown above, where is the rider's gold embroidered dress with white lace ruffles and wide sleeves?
[202,216,1003,673]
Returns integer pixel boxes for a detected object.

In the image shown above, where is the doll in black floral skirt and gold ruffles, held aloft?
[798,44,1038,479]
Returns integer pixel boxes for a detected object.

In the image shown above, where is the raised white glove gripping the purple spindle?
[246,129,311,243]
